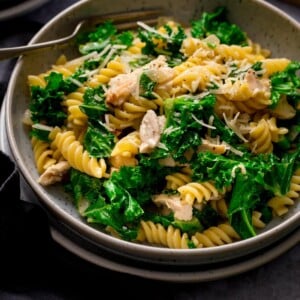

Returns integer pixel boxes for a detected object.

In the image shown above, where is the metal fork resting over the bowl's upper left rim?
[0,8,163,60]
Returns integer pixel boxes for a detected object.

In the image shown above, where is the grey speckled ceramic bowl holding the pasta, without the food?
[5,0,300,268]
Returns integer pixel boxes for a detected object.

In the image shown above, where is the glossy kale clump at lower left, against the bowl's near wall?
[65,169,142,240]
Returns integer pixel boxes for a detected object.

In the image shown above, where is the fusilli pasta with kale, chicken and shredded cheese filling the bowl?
[23,6,300,248]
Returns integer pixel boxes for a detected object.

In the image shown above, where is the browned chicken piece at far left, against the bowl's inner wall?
[38,161,70,186]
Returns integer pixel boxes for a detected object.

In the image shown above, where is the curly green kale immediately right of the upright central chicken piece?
[154,94,238,163]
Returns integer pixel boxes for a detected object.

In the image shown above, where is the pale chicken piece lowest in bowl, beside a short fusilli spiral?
[153,194,193,221]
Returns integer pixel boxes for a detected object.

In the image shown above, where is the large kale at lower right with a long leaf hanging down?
[191,149,300,238]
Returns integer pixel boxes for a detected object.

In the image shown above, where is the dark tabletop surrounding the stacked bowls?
[0,0,300,300]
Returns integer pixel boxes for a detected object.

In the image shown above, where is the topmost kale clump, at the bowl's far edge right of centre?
[191,6,247,45]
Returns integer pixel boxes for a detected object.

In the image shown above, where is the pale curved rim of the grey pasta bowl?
[5,0,300,264]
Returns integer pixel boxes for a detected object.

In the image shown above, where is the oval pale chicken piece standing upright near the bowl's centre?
[140,109,165,153]
